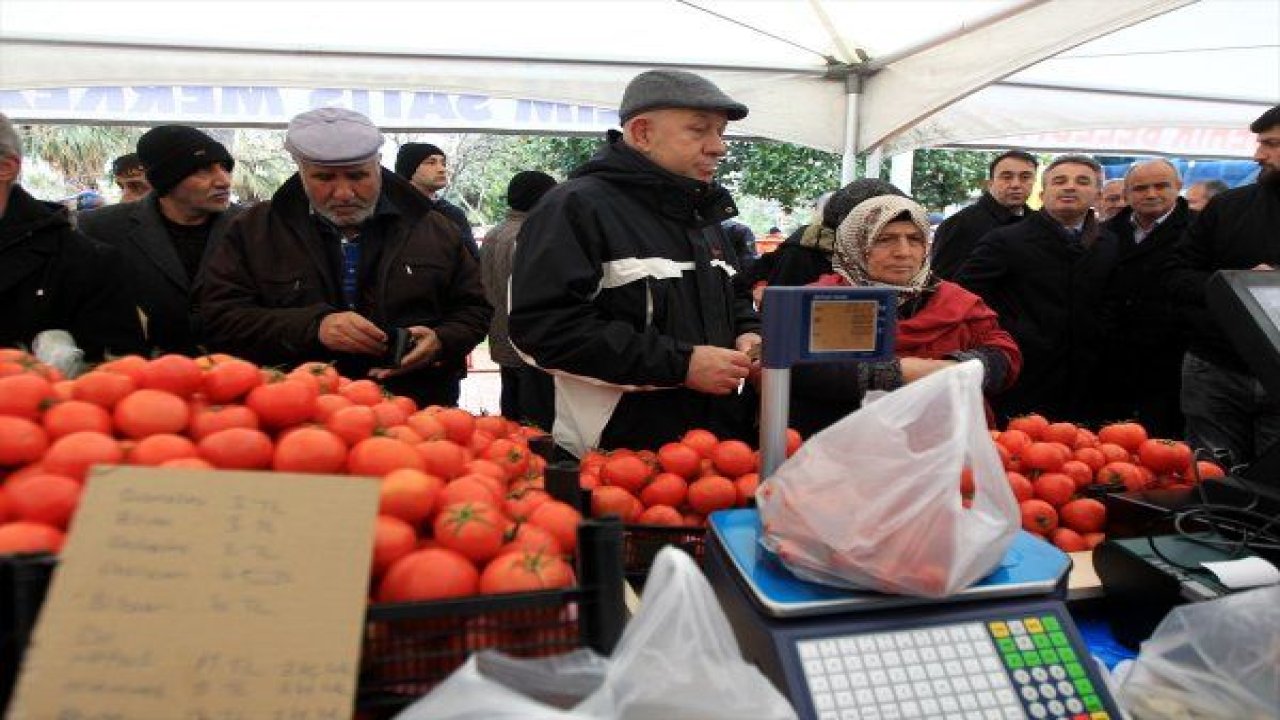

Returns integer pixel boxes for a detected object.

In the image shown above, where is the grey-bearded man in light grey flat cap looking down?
[198,108,492,405]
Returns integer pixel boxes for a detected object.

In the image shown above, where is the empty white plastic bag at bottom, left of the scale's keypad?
[398,547,796,720]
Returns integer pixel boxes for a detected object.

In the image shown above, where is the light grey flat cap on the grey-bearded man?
[284,108,383,165]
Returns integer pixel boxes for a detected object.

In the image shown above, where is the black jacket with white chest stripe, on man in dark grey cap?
[509,132,759,455]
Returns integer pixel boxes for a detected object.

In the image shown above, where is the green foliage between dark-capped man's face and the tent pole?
[719,141,840,208]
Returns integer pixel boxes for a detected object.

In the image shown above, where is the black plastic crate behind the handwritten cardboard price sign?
[0,520,627,717]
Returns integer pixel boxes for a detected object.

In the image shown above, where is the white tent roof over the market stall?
[0,0,1280,155]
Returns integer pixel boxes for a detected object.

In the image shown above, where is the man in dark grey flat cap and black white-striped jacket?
[509,70,759,456]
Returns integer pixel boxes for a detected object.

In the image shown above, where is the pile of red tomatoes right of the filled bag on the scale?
[983,414,1224,552]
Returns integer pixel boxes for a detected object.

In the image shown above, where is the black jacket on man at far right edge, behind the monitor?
[1165,182,1280,373]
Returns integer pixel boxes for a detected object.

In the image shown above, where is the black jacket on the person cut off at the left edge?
[0,186,143,361]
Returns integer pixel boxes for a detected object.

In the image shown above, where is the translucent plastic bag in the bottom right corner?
[1116,585,1280,720]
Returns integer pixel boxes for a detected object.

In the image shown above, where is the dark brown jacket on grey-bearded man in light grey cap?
[196,169,493,404]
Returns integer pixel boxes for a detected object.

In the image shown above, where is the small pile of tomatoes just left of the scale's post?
[579,428,801,528]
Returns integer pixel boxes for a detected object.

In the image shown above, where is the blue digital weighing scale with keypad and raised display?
[737,287,1121,720]
